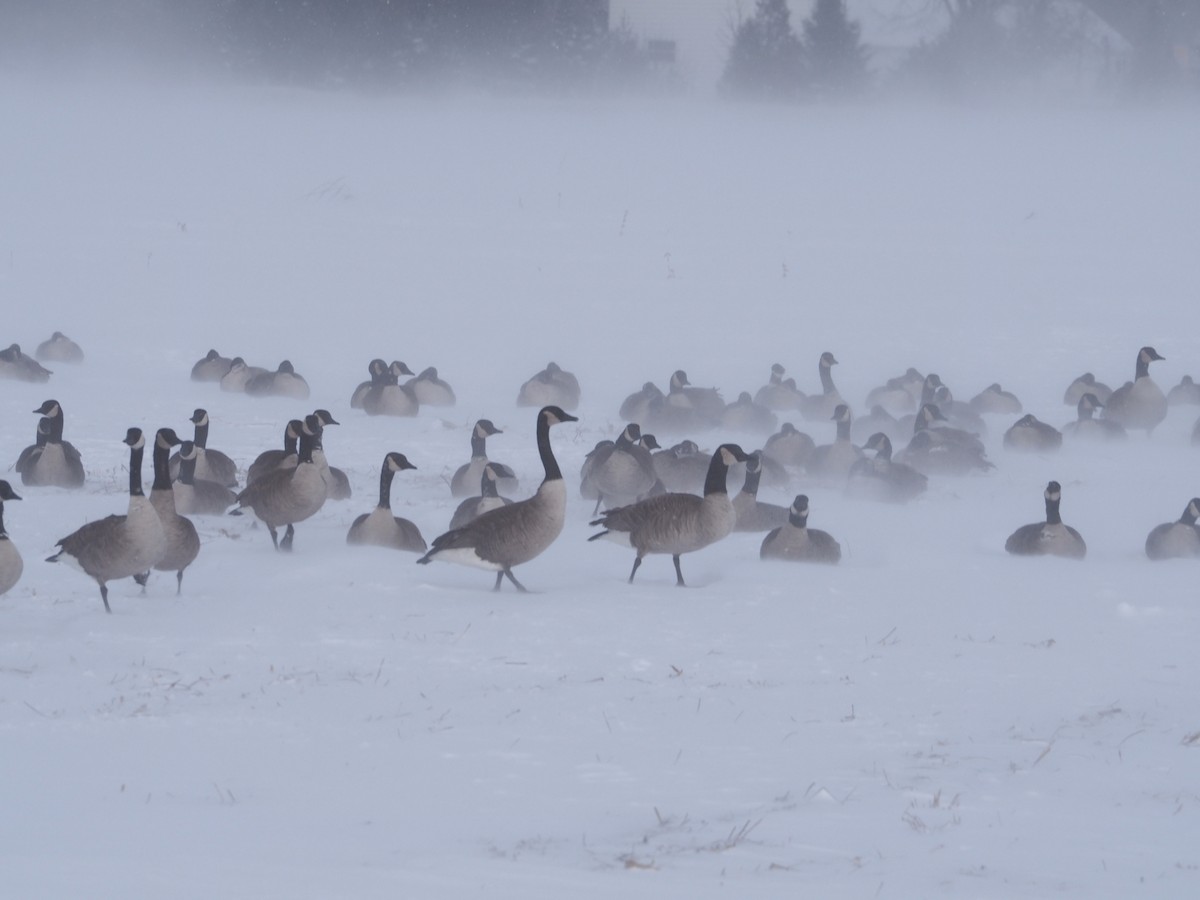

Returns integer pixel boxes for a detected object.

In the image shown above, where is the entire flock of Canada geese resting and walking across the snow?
[0,348,1200,611]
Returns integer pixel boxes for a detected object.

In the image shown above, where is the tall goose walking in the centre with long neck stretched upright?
[416,406,578,593]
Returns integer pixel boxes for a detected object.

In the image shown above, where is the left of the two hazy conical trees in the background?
[721,0,804,97]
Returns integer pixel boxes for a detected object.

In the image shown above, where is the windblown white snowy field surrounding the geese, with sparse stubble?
[0,82,1200,900]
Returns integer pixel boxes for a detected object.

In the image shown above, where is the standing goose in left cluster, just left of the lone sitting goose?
[230,415,329,551]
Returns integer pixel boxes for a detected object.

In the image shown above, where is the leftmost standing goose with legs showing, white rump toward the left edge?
[46,428,167,612]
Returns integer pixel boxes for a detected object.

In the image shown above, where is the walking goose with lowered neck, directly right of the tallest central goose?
[588,444,746,587]
